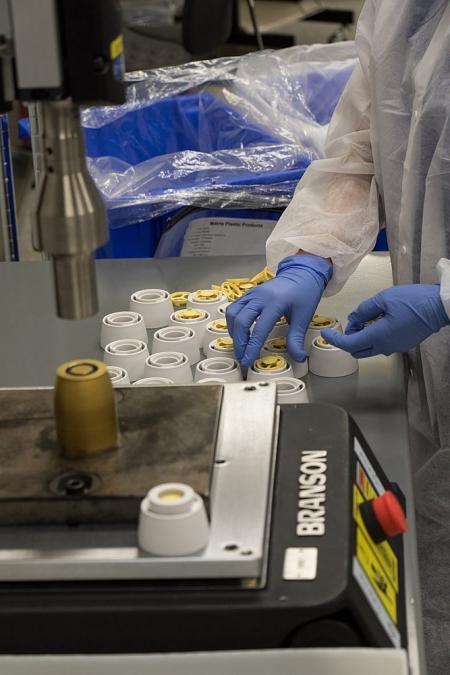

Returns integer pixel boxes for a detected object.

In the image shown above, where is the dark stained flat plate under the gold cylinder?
[0,387,222,525]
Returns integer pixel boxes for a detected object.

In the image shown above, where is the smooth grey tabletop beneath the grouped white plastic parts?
[0,254,425,675]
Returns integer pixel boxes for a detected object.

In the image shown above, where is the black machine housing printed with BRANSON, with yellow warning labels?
[0,404,407,654]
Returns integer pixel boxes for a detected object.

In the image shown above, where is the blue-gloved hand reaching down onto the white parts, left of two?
[227,255,333,366]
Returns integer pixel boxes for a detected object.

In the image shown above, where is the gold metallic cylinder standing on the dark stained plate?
[54,359,119,457]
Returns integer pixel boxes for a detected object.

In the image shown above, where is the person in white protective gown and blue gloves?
[227,0,450,675]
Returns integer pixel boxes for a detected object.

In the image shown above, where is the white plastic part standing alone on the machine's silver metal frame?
[138,483,209,556]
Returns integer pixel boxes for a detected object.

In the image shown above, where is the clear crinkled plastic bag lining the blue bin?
[83,42,356,228]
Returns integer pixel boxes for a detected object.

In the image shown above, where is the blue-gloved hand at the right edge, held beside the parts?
[321,284,450,359]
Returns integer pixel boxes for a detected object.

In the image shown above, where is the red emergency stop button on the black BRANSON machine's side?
[360,490,408,544]
